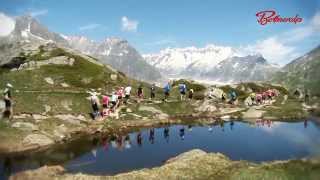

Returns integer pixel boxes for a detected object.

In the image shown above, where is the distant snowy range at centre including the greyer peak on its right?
[144,45,279,82]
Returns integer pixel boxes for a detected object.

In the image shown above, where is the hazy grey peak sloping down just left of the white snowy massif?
[64,36,161,81]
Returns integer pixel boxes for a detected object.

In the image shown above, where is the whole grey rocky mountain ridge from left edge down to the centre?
[0,16,161,81]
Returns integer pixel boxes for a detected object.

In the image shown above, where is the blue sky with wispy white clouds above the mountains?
[0,0,320,64]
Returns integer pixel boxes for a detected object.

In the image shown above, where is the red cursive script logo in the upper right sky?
[256,10,303,26]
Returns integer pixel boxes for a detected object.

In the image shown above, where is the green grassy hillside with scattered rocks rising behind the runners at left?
[0,46,158,114]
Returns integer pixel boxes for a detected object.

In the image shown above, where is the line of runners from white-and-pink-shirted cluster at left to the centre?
[88,82,194,119]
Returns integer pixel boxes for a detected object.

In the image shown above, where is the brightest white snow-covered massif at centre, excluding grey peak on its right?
[143,45,238,76]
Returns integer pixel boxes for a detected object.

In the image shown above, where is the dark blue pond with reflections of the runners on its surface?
[0,120,320,179]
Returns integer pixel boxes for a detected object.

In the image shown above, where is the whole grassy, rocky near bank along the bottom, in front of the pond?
[10,149,320,180]
